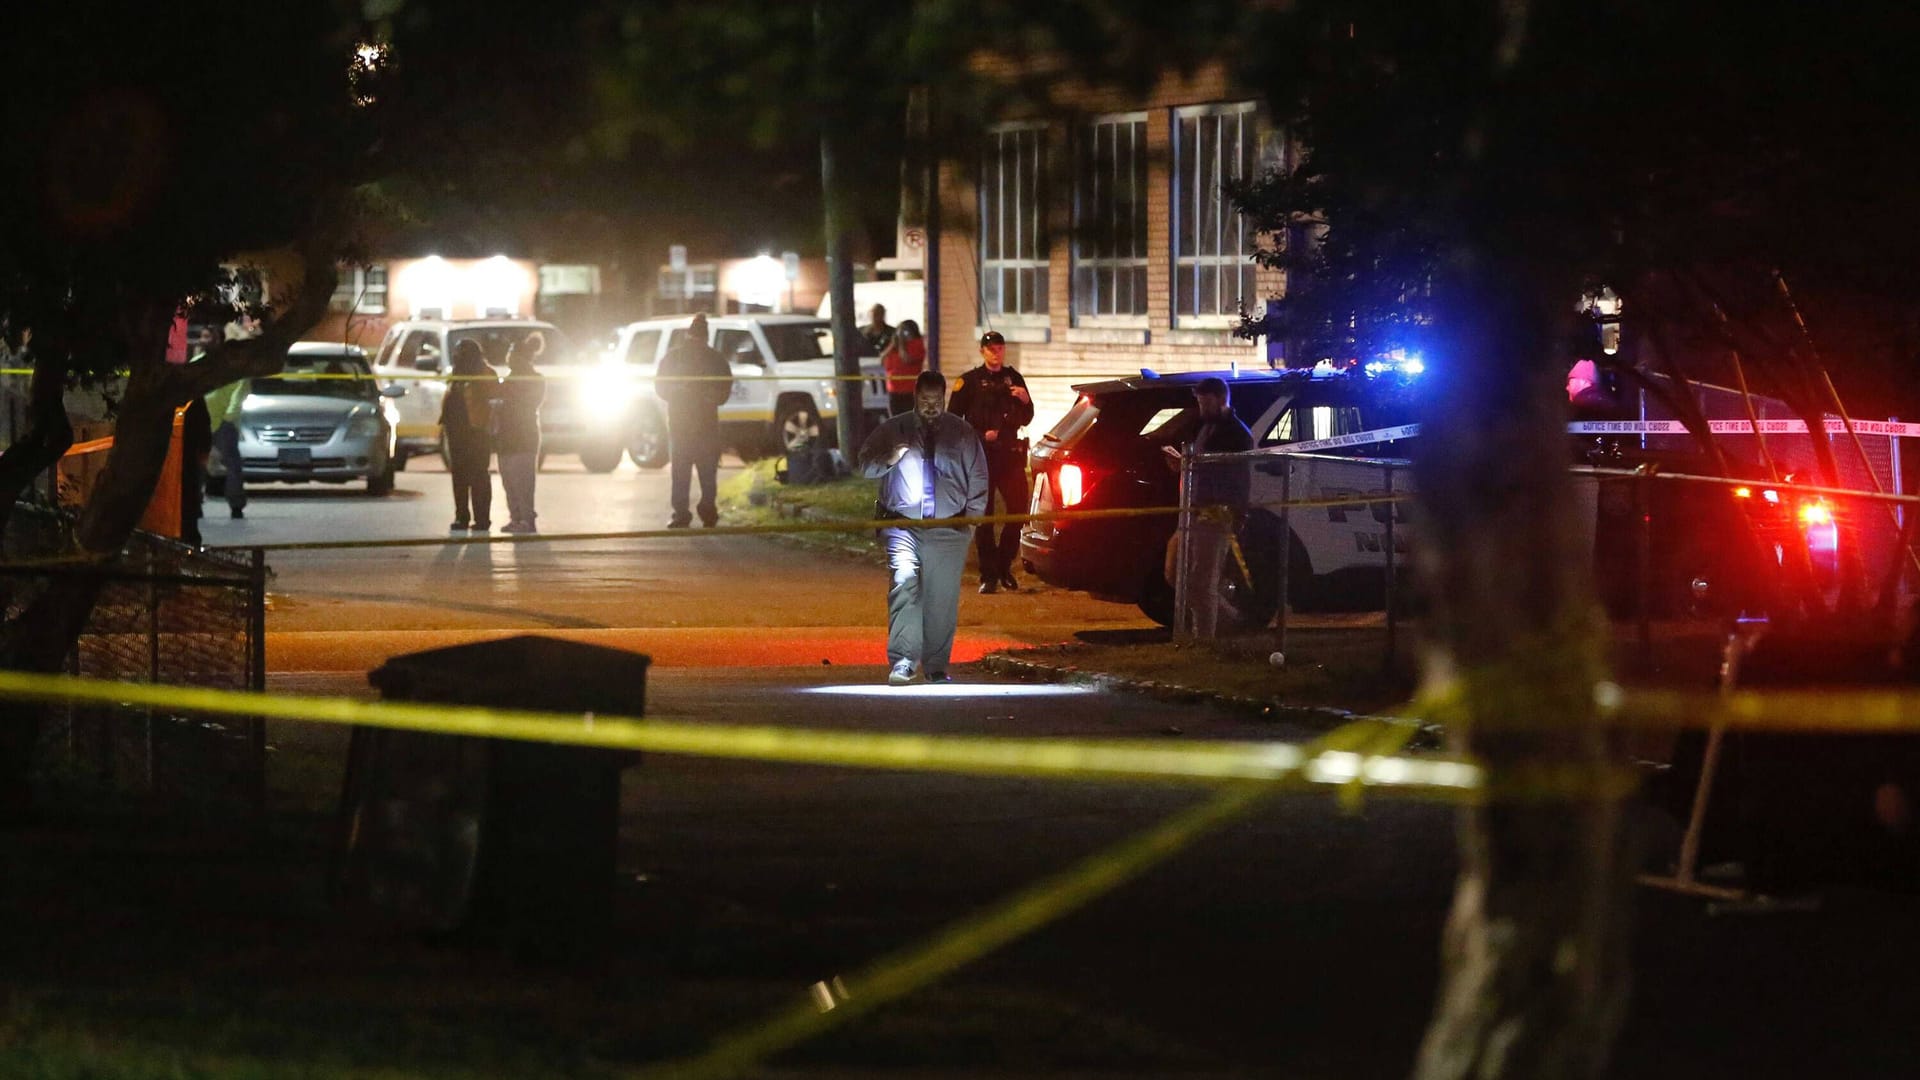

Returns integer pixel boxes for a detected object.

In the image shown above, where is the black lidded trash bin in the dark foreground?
[334,636,651,955]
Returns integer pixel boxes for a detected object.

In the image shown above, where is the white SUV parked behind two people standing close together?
[360,319,599,473]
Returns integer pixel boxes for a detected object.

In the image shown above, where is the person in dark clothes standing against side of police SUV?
[1162,377,1254,642]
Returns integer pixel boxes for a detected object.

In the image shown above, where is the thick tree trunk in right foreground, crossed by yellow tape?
[1415,265,1634,1080]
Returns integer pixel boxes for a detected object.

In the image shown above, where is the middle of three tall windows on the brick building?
[1073,113,1146,323]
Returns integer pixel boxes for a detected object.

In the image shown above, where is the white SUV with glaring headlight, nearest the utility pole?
[599,315,887,469]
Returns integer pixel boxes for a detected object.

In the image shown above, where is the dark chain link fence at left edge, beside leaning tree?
[0,505,267,807]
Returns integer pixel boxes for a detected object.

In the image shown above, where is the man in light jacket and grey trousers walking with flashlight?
[860,371,987,686]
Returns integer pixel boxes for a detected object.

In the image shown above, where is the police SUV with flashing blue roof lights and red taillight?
[1020,367,1417,625]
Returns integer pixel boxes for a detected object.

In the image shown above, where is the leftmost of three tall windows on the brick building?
[979,125,1046,319]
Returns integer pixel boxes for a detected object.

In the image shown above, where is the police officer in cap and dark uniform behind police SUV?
[948,331,1033,592]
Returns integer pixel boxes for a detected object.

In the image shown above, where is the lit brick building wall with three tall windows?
[931,67,1286,432]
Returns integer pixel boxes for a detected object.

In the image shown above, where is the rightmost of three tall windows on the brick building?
[1173,102,1260,327]
